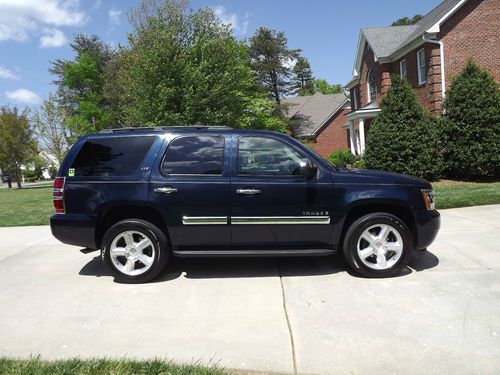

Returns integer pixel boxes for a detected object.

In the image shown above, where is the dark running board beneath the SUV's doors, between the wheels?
[173,249,335,258]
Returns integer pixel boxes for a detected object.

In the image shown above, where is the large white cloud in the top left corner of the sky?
[0,0,87,42]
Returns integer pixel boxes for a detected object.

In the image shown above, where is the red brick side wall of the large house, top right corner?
[438,0,500,87]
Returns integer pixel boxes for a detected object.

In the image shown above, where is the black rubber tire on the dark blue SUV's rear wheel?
[101,219,170,284]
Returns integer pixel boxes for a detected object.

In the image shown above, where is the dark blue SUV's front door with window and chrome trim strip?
[231,135,333,249]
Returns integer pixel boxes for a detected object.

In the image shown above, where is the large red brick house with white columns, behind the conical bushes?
[345,0,500,154]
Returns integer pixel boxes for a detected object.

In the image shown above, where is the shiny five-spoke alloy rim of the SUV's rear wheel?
[109,230,155,276]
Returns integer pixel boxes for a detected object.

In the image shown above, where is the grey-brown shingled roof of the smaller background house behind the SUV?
[283,92,349,137]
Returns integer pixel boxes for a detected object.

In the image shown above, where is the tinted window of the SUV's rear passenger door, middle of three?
[163,137,224,175]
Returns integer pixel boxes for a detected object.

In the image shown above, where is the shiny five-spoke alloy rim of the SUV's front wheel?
[357,224,403,270]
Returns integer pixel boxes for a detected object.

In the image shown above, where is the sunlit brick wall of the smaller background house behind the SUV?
[313,108,350,157]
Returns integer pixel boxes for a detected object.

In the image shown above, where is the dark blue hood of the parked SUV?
[334,169,431,189]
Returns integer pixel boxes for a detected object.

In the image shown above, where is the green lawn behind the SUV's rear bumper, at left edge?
[0,186,54,226]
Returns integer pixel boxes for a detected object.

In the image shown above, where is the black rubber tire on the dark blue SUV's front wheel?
[343,212,414,277]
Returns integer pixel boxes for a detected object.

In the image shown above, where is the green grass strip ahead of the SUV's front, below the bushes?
[432,180,500,210]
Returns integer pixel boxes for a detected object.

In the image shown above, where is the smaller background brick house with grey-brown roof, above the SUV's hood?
[283,92,350,157]
